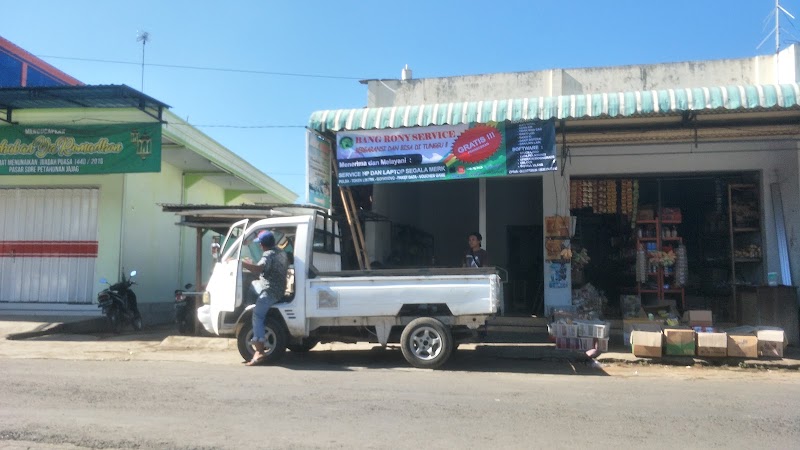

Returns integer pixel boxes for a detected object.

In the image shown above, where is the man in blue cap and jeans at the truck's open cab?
[242,230,289,366]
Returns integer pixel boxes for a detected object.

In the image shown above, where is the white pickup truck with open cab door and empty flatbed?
[184,207,503,368]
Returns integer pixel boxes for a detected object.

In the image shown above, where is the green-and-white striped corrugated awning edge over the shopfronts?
[308,83,800,132]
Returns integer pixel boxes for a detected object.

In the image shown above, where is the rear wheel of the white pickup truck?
[400,317,453,369]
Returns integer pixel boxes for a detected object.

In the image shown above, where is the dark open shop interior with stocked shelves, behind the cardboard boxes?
[570,172,764,321]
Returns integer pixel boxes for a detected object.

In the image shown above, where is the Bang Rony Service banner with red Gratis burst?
[336,120,556,186]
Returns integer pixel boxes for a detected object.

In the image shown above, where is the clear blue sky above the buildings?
[0,0,800,200]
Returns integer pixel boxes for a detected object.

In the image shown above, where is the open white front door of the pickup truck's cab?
[206,219,249,333]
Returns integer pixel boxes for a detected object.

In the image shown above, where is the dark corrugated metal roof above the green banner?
[0,85,169,110]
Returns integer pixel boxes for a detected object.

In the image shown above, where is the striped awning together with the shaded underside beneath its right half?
[308,83,800,144]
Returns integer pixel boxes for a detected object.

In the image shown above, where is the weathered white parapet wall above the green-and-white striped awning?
[367,44,800,107]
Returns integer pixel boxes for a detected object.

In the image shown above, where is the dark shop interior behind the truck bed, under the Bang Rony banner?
[333,176,544,316]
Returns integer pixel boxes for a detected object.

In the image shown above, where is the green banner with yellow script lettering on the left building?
[0,122,161,175]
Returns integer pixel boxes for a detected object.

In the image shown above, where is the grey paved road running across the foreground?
[0,336,800,449]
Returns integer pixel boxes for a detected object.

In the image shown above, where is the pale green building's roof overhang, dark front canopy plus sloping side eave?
[0,85,297,203]
